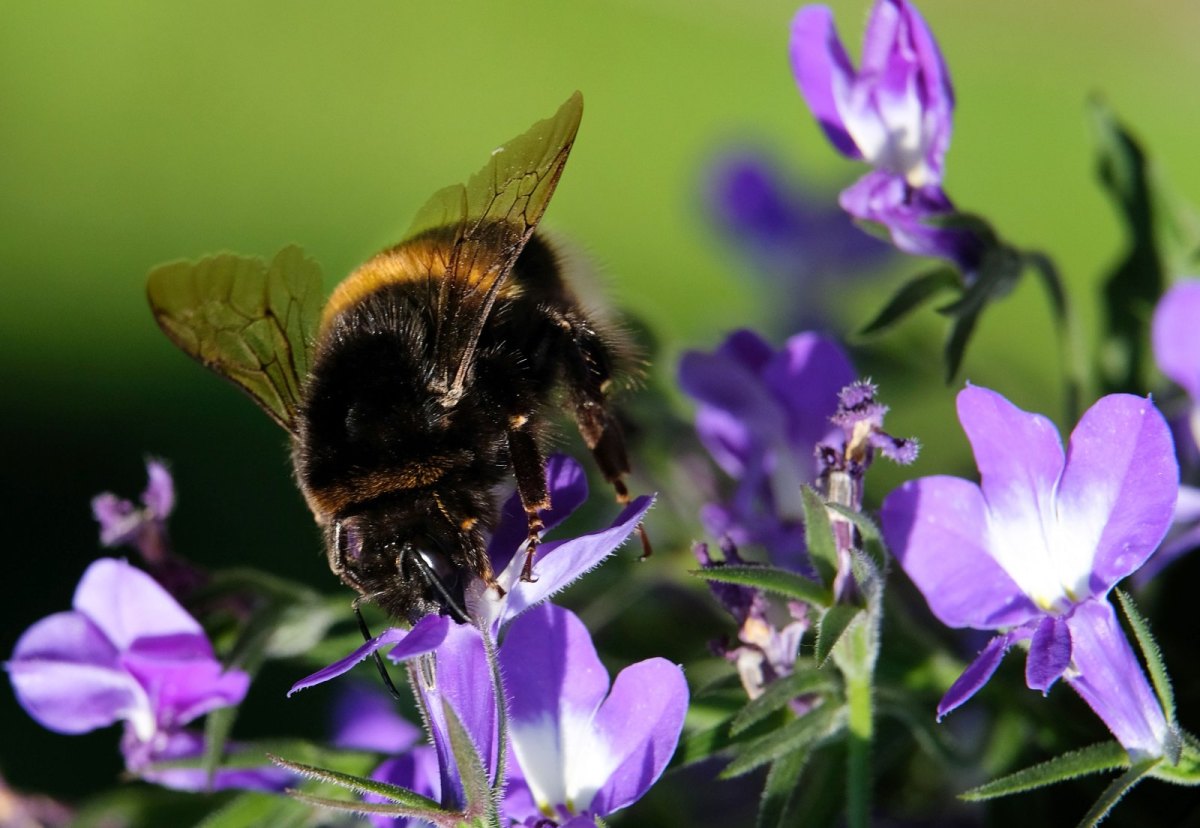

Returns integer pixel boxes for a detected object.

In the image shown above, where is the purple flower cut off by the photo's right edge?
[1138,280,1200,573]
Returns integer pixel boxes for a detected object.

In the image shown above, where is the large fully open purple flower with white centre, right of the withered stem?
[882,386,1178,758]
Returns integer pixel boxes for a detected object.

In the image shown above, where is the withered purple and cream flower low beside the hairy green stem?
[692,540,809,700]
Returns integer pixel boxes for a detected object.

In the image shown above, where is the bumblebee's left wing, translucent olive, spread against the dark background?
[146,247,322,432]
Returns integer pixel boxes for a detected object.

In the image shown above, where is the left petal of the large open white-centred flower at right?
[880,476,1039,630]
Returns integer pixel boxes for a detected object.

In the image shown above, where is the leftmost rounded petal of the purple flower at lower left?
[6,612,142,733]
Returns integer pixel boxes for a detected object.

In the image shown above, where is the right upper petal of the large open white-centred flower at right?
[1057,394,1180,592]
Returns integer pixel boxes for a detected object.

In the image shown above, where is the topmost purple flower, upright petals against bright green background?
[790,0,983,272]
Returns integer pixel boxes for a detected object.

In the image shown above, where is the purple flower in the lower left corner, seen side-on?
[6,558,270,787]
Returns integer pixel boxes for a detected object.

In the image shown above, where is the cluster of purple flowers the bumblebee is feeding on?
[292,457,688,828]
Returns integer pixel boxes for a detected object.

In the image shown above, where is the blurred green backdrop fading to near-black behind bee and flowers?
[7,0,1200,820]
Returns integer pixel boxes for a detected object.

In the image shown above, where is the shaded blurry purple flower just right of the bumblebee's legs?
[679,330,854,571]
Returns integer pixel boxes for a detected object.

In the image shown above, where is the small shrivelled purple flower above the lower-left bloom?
[91,460,208,600]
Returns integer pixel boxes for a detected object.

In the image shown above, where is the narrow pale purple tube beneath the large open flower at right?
[1067,600,1168,761]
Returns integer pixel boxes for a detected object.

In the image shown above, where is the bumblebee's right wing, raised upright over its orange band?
[409,92,583,404]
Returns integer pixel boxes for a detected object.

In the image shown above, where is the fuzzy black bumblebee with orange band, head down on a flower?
[148,92,629,622]
